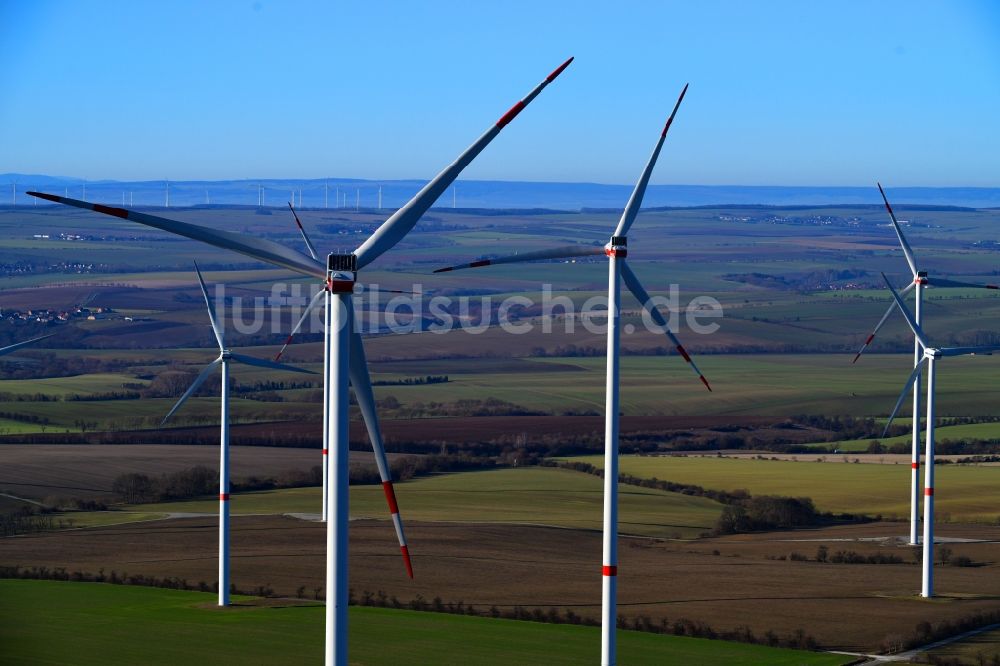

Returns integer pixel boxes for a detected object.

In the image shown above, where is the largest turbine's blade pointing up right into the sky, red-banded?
[354,58,573,269]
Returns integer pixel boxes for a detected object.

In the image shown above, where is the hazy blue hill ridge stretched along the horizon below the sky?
[0,173,1000,211]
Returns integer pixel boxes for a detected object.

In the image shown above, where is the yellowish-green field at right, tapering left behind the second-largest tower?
[572,456,1000,523]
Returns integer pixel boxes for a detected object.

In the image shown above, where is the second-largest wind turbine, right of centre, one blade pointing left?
[434,85,712,666]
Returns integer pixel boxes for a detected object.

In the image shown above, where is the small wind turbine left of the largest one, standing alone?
[160,262,316,606]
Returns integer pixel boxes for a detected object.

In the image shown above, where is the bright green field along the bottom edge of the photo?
[0,580,850,666]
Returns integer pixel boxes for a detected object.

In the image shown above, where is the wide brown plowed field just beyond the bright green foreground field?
[0,516,1000,650]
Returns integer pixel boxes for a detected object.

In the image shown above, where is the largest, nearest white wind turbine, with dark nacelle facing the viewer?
[29,58,573,666]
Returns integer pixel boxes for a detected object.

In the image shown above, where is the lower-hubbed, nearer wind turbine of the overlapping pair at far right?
[882,273,1000,597]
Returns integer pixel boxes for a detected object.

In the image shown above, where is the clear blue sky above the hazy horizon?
[0,0,1000,187]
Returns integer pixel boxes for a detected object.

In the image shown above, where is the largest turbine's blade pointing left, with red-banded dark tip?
[28,192,326,280]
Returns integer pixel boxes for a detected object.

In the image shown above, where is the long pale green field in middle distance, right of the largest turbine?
[358,352,1000,417]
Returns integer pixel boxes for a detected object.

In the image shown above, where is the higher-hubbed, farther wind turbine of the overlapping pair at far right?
[852,183,998,546]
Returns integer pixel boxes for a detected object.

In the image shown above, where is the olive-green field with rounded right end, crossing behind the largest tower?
[132,468,722,537]
